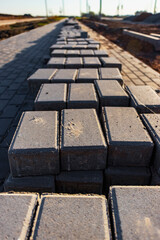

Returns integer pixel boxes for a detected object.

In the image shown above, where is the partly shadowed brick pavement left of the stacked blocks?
[0,22,62,185]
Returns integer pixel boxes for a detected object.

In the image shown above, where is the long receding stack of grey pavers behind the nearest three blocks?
[5,17,160,194]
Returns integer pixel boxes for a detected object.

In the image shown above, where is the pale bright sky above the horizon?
[0,0,160,16]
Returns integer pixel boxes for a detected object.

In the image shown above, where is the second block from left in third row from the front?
[67,83,99,110]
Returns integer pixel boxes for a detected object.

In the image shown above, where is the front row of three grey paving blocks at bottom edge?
[0,186,160,240]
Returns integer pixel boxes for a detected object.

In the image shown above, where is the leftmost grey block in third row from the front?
[34,83,67,111]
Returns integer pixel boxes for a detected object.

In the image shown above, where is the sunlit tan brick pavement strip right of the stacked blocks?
[80,24,160,90]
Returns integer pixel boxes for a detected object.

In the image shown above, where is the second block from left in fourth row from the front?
[51,69,77,83]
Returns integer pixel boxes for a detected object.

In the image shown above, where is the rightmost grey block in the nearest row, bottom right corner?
[109,186,160,240]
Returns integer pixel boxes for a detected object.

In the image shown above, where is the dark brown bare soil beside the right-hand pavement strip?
[81,19,160,73]
